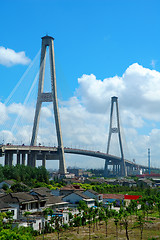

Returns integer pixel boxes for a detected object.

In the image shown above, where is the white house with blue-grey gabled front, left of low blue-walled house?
[62,191,95,207]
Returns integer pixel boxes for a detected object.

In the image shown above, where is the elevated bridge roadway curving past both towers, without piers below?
[0,144,158,170]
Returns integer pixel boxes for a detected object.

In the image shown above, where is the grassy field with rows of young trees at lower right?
[36,193,160,240]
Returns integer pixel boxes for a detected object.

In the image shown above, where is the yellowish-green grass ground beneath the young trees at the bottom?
[36,216,160,240]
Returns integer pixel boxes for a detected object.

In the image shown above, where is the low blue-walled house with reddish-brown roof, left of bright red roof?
[103,194,124,207]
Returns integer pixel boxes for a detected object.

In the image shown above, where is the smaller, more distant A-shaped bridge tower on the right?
[104,96,127,176]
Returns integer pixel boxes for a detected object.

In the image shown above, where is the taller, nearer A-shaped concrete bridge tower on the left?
[30,36,66,175]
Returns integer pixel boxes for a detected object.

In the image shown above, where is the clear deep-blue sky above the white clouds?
[0,0,160,89]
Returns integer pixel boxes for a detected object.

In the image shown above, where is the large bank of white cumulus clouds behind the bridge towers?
[0,63,160,167]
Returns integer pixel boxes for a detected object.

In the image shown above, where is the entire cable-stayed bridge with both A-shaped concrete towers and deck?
[0,36,156,176]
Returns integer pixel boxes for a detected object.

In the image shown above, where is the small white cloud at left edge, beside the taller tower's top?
[0,46,31,67]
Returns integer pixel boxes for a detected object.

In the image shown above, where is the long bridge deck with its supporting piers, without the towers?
[0,145,158,176]
